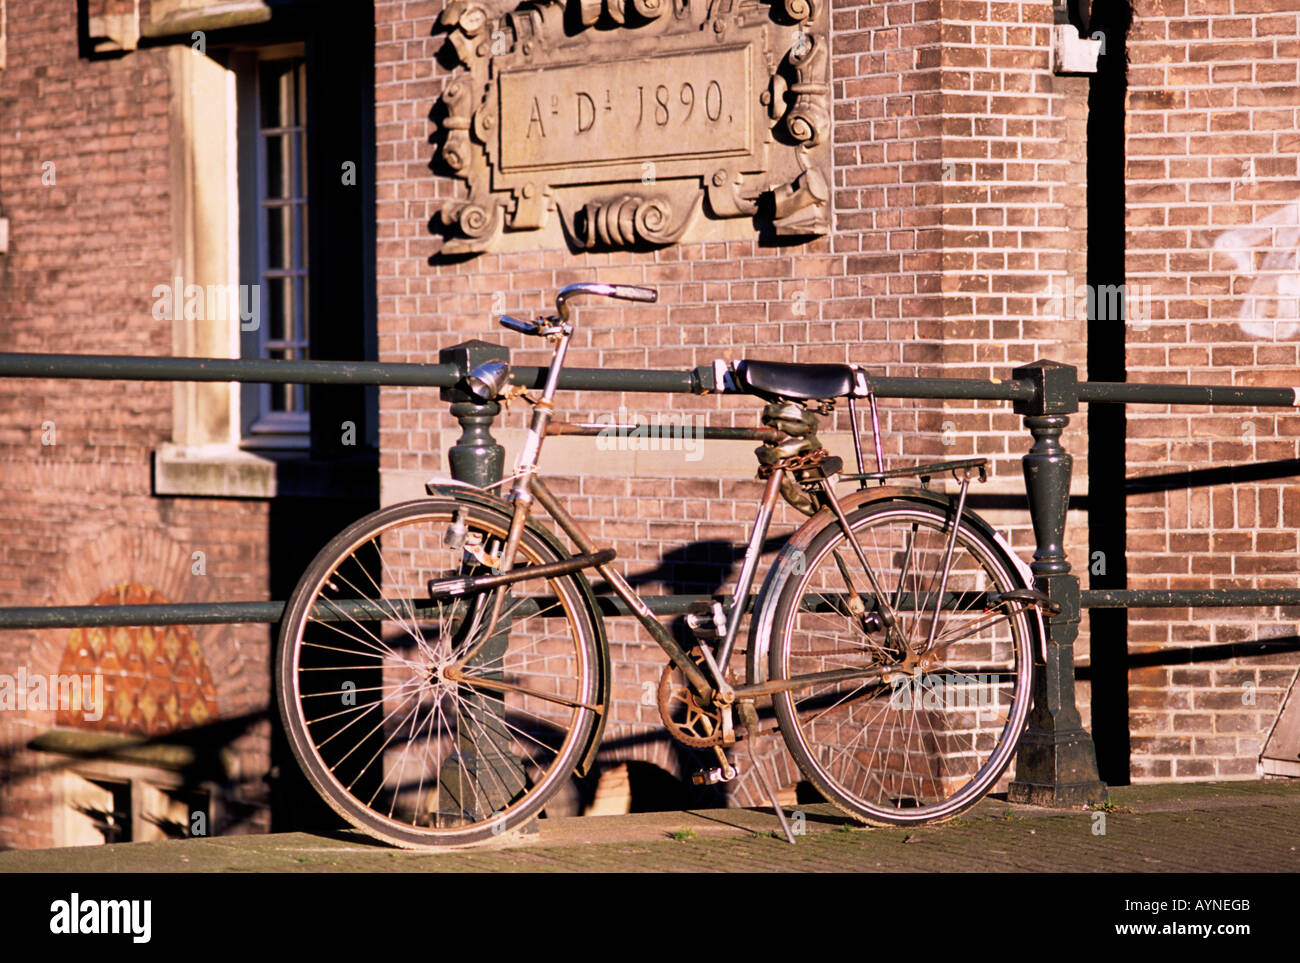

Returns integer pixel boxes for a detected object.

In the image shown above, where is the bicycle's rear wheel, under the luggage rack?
[768,499,1034,825]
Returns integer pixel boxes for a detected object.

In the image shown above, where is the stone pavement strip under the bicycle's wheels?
[0,780,1300,873]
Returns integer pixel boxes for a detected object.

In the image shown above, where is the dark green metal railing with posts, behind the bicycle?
[0,342,1300,806]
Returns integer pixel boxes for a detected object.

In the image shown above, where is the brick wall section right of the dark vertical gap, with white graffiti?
[1125,0,1300,780]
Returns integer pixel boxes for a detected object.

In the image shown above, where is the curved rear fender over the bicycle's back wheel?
[745,485,1047,682]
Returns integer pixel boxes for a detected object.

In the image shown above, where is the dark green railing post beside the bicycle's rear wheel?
[1008,361,1106,808]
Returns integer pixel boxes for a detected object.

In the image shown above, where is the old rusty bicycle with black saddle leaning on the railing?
[276,283,1052,847]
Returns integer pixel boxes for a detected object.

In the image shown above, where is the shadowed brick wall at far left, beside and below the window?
[0,0,269,847]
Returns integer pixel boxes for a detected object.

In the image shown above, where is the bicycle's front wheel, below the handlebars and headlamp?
[277,498,603,847]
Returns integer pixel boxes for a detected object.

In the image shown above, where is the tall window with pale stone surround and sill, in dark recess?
[153,4,378,498]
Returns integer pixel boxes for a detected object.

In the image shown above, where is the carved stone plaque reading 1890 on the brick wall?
[437,0,831,253]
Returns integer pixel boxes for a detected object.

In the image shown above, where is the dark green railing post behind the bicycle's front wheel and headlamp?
[438,340,527,820]
